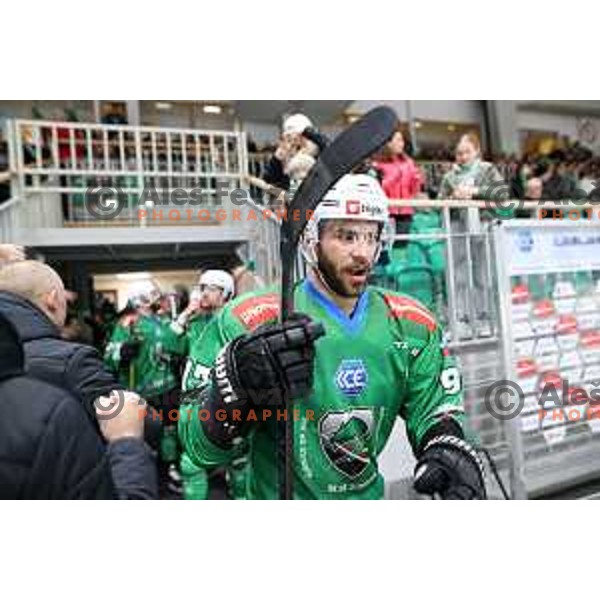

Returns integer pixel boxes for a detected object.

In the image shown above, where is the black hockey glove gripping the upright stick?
[201,315,325,447]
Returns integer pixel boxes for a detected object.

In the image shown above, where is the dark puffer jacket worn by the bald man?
[0,292,161,448]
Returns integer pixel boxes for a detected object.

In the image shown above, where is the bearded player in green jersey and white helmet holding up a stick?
[179,175,485,499]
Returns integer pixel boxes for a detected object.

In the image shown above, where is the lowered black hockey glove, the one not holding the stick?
[414,435,486,500]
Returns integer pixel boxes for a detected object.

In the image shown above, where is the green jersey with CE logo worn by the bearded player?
[179,280,464,499]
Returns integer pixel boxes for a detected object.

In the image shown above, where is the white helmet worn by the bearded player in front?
[301,174,390,266]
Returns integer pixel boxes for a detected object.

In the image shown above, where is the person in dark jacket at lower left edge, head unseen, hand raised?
[0,315,157,500]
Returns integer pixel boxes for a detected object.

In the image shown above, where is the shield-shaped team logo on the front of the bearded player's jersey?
[319,409,373,478]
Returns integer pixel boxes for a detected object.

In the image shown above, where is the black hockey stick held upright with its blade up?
[276,106,398,500]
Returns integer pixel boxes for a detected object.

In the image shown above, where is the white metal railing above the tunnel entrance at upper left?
[9,120,247,226]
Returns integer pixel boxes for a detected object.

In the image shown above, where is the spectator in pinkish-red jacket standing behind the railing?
[373,123,423,246]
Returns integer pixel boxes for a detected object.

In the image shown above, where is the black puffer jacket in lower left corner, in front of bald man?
[0,315,115,499]
